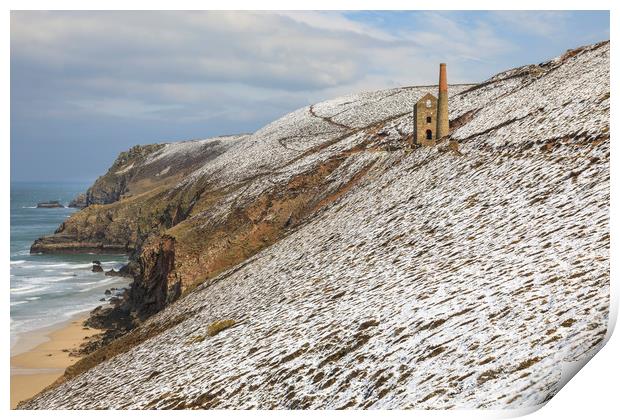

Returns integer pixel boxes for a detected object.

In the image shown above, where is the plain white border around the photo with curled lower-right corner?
[0,0,620,419]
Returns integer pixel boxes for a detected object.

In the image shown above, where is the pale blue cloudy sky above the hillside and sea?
[11,11,609,181]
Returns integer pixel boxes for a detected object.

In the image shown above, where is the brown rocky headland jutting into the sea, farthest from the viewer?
[31,136,243,253]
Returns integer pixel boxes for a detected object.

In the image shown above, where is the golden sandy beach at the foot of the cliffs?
[11,314,101,409]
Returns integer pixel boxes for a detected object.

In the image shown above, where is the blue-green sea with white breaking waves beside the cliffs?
[10,182,130,355]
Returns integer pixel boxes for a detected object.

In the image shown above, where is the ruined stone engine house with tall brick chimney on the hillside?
[413,63,450,146]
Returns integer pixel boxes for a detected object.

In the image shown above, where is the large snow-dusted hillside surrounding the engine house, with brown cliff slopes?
[22,43,610,408]
